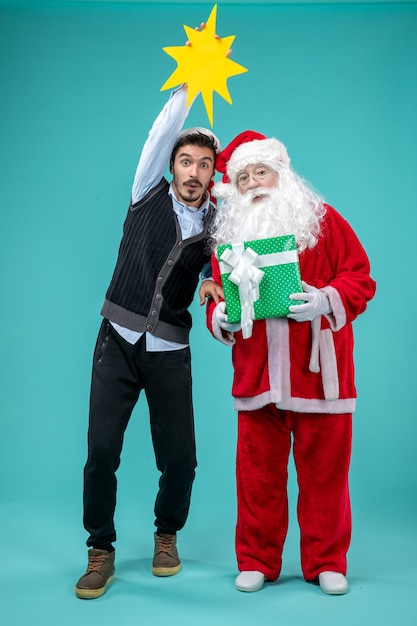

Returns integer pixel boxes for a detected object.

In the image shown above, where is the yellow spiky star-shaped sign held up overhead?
[161,4,247,126]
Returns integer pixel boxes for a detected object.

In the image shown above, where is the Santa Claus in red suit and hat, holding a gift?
[201,131,375,594]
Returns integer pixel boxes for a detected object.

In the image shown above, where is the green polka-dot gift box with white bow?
[218,235,303,337]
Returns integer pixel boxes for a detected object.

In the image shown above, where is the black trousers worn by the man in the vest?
[84,320,197,550]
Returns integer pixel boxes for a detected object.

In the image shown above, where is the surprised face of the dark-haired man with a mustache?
[170,144,214,208]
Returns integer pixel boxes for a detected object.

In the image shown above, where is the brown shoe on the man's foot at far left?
[75,548,115,600]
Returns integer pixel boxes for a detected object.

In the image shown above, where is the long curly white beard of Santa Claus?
[212,171,325,252]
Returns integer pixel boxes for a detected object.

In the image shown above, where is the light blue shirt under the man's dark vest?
[111,88,210,352]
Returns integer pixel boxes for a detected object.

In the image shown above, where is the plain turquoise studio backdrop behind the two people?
[0,1,417,626]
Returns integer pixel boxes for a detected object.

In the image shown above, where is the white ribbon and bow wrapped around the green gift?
[219,243,298,339]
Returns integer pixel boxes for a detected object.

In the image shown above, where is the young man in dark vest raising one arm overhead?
[75,87,220,598]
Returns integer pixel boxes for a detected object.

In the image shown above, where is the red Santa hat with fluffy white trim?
[216,130,290,183]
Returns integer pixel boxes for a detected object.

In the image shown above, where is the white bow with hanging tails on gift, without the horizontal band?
[220,243,265,339]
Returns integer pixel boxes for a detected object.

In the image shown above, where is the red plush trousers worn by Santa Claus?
[236,404,352,581]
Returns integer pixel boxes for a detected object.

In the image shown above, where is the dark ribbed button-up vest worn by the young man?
[101,178,214,343]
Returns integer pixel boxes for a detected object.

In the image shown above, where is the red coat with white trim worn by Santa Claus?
[207,206,376,413]
